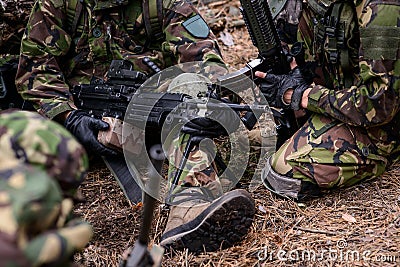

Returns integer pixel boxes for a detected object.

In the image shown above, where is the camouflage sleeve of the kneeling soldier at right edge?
[307,2,400,127]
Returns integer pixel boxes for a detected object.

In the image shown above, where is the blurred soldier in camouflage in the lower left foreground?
[0,110,92,266]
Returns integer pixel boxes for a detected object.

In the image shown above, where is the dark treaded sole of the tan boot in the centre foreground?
[160,189,255,253]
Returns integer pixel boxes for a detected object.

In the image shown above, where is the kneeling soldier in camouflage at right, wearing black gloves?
[256,0,400,199]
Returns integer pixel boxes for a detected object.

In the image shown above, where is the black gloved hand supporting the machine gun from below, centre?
[181,109,240,138]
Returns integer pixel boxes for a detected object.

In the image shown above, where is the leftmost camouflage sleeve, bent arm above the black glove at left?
[16,0,74,118]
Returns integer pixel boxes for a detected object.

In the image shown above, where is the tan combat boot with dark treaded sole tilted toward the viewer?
[160,181,255,253]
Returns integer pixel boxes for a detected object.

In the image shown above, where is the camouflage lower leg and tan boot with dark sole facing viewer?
[161,133,255,252]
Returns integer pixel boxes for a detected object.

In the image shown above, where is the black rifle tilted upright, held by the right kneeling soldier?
[219,0,304,147]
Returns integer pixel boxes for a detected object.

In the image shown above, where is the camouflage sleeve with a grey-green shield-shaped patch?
[162,0,226,77]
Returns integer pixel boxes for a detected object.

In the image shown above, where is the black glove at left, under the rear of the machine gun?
[64,110,118,156]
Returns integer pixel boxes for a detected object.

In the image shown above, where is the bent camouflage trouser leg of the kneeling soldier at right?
[271,114,388,188]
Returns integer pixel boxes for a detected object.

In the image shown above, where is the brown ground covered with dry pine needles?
[75,0,400,267]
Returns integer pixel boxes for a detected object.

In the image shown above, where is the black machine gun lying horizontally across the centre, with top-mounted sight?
[71,60,270,196]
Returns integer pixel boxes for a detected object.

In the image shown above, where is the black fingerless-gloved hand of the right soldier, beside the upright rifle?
[260,67,309,110]
